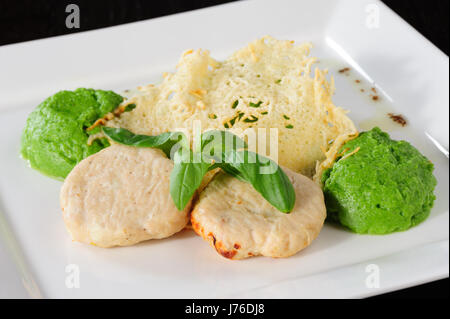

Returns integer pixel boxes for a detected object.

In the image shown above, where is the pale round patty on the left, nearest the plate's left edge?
[60,145,191,247]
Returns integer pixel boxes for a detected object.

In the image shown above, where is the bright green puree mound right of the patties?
[322,127,436,234]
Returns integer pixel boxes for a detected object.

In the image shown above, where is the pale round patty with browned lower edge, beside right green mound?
[191,169,326,259]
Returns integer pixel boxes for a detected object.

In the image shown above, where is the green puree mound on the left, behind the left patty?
[21,89,123,179]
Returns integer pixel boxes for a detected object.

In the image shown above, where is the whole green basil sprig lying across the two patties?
[103,127,295,213]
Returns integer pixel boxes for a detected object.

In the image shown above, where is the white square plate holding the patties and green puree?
[0,0,449,298]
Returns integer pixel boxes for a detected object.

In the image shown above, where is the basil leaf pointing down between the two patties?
[170,148,211,210]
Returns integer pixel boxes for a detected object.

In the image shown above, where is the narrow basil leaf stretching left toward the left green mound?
[103,127,189,158]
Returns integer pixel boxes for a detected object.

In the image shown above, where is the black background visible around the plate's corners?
[0,0,449,298]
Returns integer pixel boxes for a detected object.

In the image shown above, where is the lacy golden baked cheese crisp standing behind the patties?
[107,36,356,177]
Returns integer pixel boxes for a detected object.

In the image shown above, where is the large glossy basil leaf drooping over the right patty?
[218,150,295,213]
